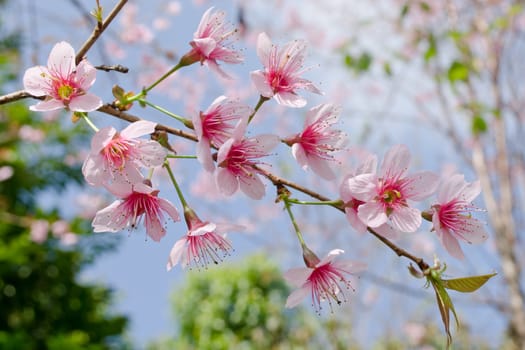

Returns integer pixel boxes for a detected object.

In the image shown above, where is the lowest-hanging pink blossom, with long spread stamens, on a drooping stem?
[284,249,366,313]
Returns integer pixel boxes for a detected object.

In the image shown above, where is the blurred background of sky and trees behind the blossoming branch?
[0,0,525,349]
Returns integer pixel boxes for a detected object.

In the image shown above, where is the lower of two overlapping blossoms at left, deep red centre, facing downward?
[92,180,180,242]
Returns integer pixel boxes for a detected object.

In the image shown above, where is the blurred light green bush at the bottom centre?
[149,255,321,350]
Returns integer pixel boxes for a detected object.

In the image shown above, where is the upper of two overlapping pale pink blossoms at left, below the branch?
[82,120,167,186]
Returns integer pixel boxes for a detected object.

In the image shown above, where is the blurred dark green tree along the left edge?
[0,1,127,350]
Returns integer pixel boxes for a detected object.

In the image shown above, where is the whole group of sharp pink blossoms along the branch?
[20,8,487,311]
